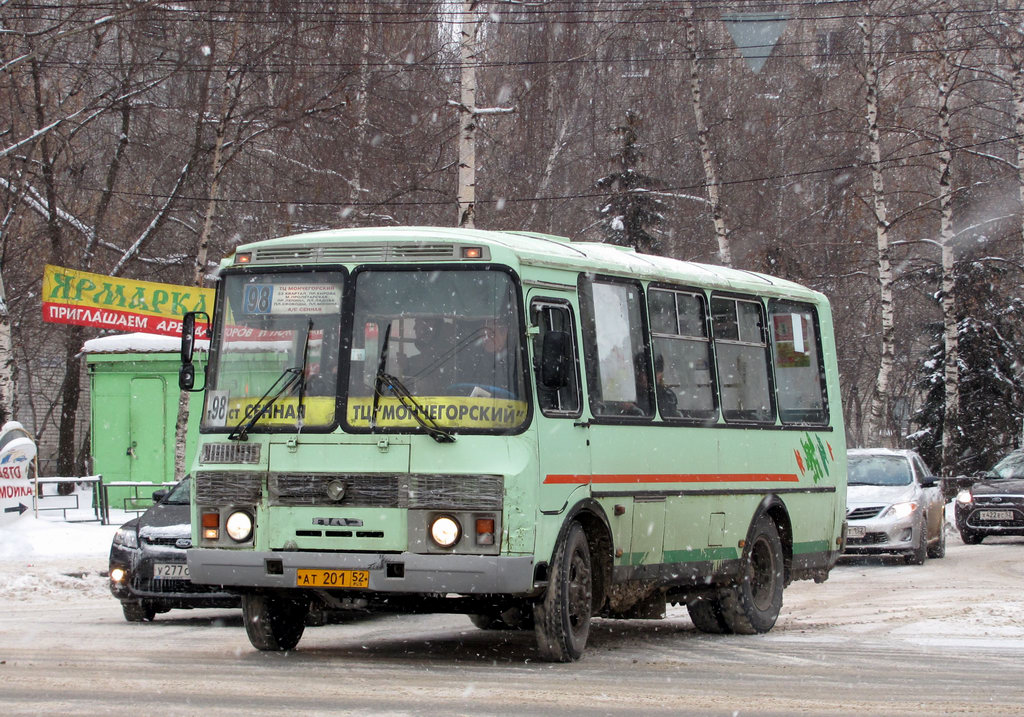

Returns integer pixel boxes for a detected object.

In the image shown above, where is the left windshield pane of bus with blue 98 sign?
[203,271,344,432]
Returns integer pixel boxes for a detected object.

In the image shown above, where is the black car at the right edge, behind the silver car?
[955,450,1024,545]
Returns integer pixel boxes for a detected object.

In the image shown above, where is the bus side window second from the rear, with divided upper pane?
[711,296,774,423]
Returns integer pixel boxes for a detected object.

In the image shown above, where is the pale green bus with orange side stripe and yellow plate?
[180,227,846,662]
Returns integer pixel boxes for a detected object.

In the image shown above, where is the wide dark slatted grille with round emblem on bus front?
[267,473,504,510]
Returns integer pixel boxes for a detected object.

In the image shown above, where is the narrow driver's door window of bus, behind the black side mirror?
[529,300,581,418]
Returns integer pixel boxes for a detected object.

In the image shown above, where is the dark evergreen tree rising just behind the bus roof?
[595,110,666,254]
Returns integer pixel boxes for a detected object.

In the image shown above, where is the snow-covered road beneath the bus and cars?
[0,518,1024,715]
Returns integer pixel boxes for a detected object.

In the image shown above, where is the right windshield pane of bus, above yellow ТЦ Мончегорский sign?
[345,269,527,431]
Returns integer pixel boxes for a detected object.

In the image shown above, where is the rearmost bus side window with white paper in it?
[769,301,828,425]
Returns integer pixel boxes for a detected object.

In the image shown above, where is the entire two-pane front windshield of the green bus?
[203,269,527,439]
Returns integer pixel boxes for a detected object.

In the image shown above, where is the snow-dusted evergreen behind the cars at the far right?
[909,262,1024,474]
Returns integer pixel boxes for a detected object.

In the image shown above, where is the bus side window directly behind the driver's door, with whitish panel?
[581,279,654,419]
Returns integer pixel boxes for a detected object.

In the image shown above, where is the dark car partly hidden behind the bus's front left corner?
[110,477,240,623]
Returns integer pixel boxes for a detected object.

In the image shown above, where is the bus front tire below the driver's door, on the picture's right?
[534,520,594,663]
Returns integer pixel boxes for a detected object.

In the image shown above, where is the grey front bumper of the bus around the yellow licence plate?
[188,549,534,595]
